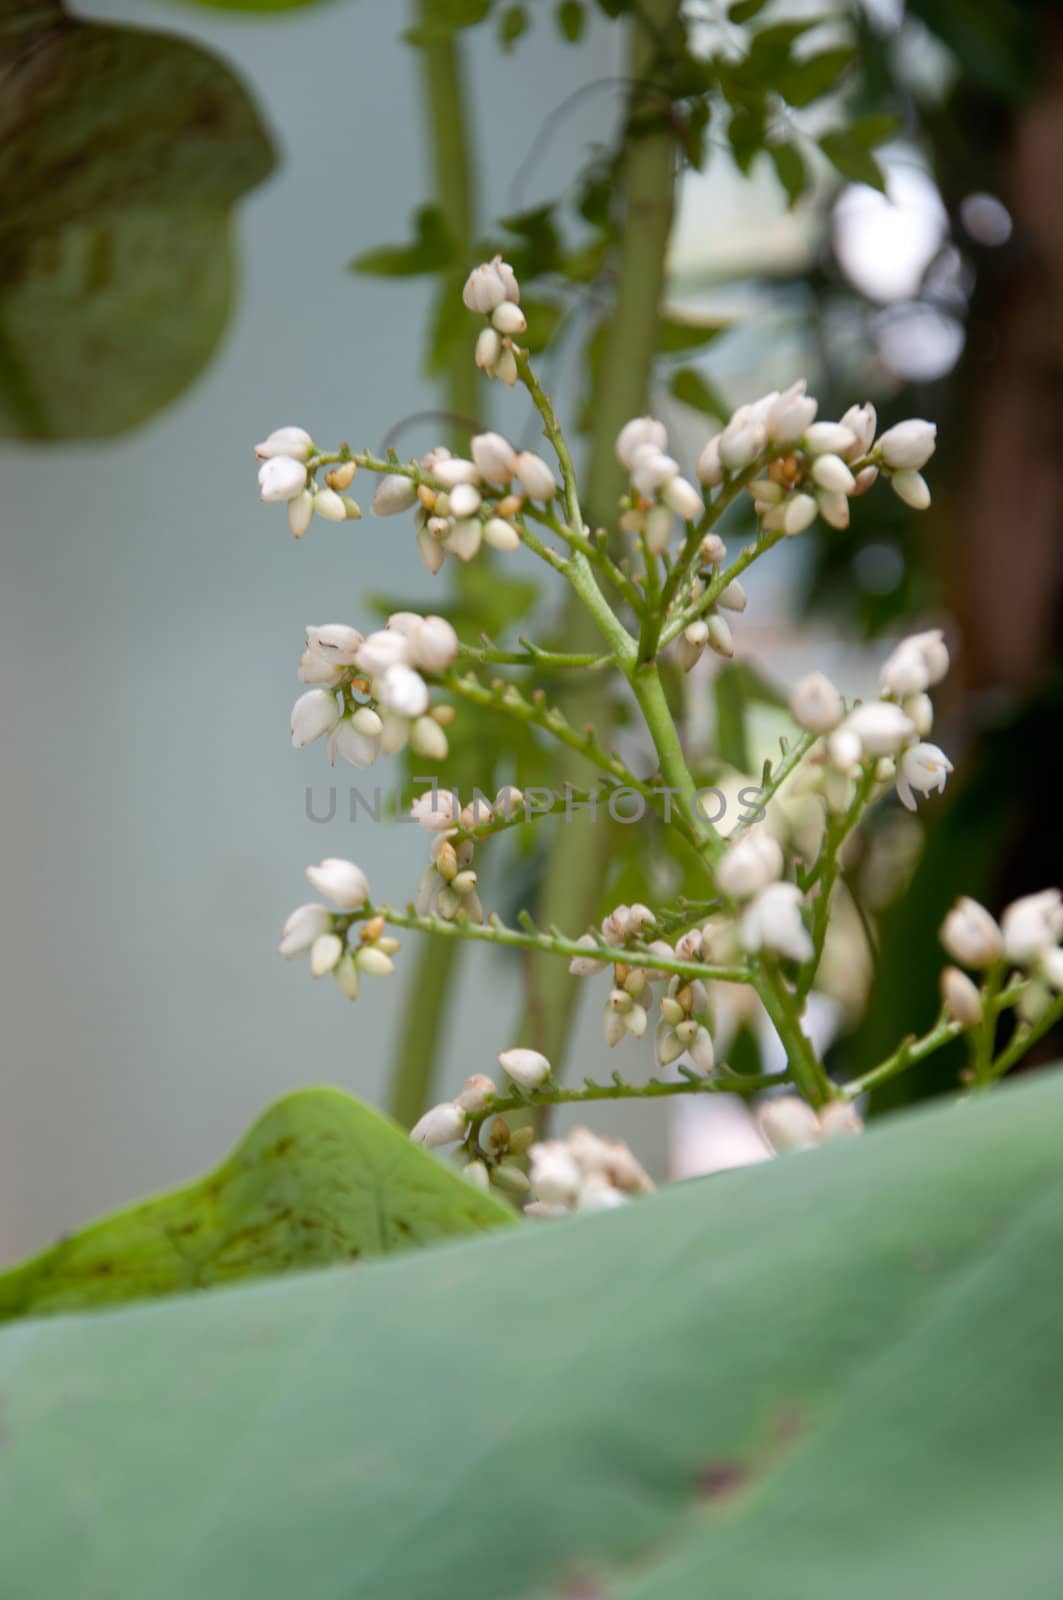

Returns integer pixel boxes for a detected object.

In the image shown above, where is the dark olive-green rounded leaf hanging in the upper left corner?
[0,3,272,438]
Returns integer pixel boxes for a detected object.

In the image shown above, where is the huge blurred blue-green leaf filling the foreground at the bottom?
[0,1074,1063,1600]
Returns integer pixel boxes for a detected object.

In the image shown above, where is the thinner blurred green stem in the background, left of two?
[389,0,480,1126]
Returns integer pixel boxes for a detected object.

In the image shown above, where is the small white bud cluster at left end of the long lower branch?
[280,856,399,1000]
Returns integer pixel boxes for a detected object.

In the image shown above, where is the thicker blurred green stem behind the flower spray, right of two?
[517,0,679,1072]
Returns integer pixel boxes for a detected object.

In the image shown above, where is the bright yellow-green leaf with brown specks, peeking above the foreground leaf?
[0,1090,514,1320]
